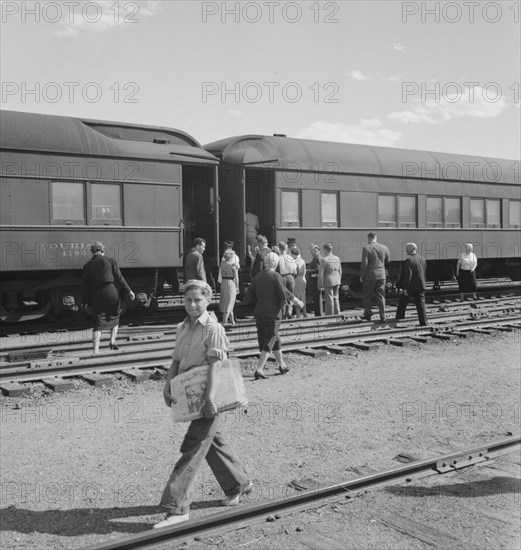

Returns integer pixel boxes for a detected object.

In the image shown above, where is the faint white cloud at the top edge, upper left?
[53,0,161,37]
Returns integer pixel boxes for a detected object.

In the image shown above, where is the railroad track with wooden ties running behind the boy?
[0,298,521,396]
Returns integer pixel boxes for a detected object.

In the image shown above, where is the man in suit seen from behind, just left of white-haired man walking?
[360,232,391,323]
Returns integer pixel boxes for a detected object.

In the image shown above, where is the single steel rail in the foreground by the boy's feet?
[85,436,521,550]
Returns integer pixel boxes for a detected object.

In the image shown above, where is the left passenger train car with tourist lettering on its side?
[0,111,219,322]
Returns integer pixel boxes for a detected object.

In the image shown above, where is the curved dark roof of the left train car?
[0,111,219,164]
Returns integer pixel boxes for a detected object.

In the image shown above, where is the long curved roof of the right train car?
[204,135,520,184]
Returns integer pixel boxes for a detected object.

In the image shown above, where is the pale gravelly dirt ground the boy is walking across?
[0,331,521,550]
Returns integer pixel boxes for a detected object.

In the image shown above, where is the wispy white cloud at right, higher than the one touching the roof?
[387,86,507,124]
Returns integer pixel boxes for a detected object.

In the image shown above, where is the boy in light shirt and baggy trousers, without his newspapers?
[154,280,253,528]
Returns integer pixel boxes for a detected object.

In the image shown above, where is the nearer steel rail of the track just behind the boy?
[0,308,520,383]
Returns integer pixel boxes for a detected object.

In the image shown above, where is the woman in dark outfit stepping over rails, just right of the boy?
[242,252,304,380]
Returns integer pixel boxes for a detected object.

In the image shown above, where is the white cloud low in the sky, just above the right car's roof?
[296,118,402,147]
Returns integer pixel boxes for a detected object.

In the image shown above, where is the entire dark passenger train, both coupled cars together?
[0,111,521,322]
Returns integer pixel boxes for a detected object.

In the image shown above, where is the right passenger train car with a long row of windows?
[205,135,521,287]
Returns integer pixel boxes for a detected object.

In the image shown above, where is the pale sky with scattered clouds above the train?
[0,0,521,159]
